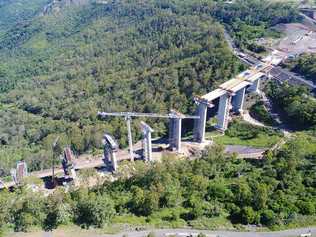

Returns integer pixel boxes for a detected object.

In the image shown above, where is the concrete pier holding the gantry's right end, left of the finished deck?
[169,118,182,152]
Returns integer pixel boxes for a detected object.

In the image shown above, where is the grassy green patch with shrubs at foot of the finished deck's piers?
[206,120,283,148]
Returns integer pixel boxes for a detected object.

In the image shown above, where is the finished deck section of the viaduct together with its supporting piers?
[194,51,287,142]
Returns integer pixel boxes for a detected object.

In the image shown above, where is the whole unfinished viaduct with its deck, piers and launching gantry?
[0,44,302,190]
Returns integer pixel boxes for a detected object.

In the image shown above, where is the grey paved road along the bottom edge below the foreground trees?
[100,227,316,237]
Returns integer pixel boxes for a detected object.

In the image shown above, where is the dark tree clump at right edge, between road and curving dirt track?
[268,83,316,129]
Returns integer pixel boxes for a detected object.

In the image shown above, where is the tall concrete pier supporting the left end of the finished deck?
[193,103,207,143]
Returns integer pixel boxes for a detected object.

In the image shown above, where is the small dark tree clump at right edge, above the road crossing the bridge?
[285,54,316,83]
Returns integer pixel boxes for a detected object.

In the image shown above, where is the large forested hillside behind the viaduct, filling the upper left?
[0,0,297,175]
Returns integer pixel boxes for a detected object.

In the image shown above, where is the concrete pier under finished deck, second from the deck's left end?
[216,94,231,131]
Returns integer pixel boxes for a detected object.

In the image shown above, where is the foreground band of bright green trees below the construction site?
[0,141,316,231]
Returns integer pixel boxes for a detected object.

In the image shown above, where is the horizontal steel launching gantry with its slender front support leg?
[98,110,200,161]
